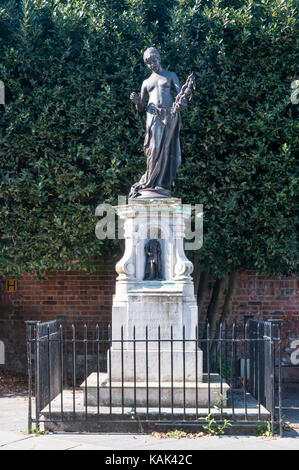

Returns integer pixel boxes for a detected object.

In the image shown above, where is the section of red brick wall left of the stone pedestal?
[0,259,116,371]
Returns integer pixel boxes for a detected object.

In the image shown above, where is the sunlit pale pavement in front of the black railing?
[0,387,299,451]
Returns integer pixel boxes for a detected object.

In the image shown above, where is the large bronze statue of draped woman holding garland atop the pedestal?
[129,47,195,198]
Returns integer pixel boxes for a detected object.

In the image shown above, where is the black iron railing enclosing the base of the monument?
[27,320,282,435]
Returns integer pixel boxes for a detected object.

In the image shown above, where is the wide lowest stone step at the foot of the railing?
[42,390,270,434]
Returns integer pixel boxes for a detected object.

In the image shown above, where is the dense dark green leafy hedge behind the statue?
[0,0,298,277]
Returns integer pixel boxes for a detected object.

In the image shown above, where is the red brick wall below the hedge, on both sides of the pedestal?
[0,259,299,380]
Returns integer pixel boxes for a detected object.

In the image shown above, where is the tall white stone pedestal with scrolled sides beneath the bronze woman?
[82,198,227,407]
